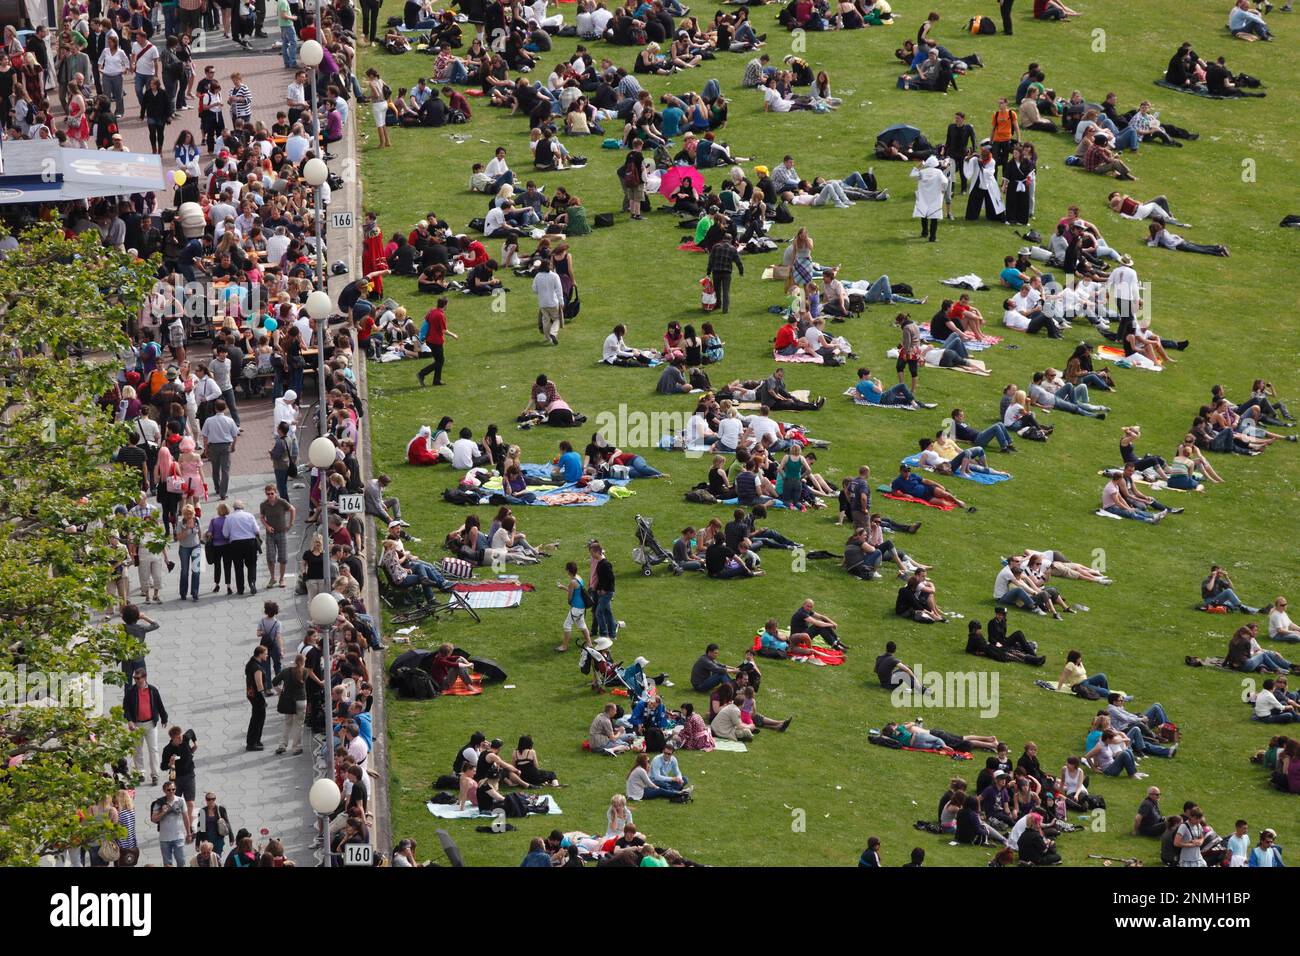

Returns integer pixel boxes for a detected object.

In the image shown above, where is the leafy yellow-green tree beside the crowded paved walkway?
[0,224,161,866]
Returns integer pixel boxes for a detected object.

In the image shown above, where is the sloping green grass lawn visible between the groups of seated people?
[359,0,1300,866]
